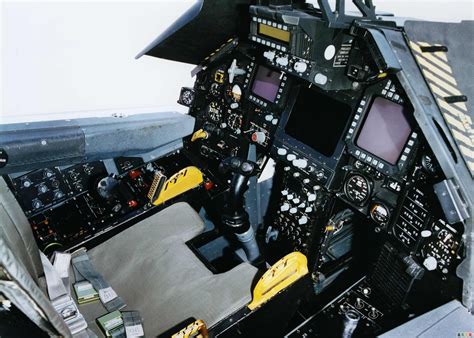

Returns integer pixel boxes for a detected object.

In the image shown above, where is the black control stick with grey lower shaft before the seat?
[219,157,260,262]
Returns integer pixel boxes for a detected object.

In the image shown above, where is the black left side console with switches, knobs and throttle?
[7,154,193,253]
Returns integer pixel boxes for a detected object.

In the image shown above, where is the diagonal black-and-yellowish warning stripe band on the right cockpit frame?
[410,41,474,177]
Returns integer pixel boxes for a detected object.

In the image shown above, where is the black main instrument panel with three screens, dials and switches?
[180,2,463,333]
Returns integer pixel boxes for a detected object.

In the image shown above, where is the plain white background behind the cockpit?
[0,0,474,123]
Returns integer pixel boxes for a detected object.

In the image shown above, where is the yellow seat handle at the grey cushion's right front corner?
[247,252,308,311]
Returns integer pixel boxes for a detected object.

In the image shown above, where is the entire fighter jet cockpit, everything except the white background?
[0,0,474,338]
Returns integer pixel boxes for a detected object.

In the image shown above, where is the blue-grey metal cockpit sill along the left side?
[0,112,194,174]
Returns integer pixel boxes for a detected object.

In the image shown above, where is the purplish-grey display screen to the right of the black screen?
[356,97,411,164]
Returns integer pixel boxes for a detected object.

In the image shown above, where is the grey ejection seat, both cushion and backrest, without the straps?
[0,179,257,336]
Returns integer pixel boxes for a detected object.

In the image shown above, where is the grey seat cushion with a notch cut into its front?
[76,203,257,336]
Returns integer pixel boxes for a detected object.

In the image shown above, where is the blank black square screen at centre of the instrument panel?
[285,86,351,157]
